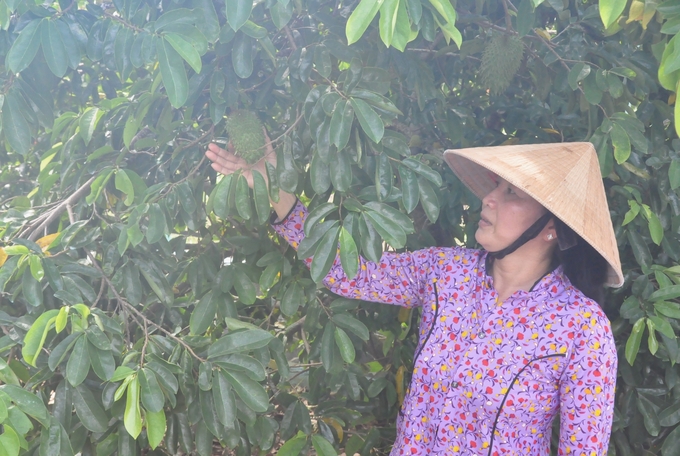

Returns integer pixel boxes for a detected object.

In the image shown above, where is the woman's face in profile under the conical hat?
[475,177,546,252]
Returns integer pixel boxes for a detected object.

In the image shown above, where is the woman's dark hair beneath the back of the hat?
[555,222,608,305]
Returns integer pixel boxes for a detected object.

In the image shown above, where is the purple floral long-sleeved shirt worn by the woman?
[275,202,617,456]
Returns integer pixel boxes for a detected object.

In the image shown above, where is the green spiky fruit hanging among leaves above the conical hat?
[482,33,524,94]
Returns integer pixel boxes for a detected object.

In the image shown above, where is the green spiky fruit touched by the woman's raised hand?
[226,110,265,165]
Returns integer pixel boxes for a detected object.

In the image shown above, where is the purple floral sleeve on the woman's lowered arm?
[558,303,617,456]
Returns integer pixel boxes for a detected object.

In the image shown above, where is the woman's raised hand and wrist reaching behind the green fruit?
[205,133,297,220]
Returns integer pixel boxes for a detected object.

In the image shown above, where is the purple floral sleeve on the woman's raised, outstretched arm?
[272,201,432,307]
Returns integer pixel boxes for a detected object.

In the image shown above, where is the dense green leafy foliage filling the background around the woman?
[0,0,680,456]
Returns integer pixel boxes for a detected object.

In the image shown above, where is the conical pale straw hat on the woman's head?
[444,142,623,287]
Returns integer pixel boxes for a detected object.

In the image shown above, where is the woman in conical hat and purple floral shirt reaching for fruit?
[207,143,623,456]
